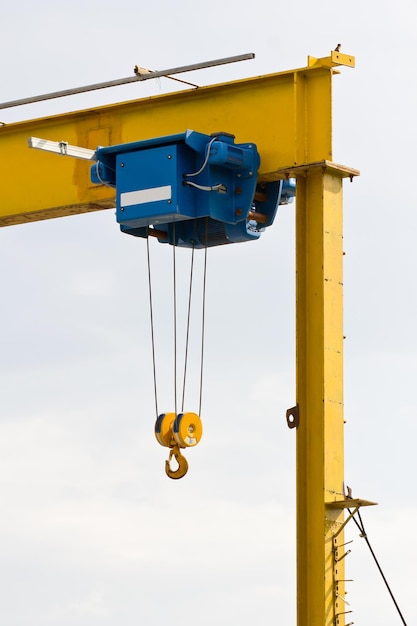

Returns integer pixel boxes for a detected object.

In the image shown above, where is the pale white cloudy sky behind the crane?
[0,0,417,626]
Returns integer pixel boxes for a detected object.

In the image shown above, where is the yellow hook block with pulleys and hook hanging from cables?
[155,413,203,479]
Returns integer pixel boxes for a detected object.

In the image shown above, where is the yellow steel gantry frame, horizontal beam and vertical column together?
[0,49,373,626]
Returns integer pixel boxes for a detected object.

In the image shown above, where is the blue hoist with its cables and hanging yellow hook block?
[29,130,295,478]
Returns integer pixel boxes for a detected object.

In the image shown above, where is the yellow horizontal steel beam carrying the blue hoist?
[0,53,353,226]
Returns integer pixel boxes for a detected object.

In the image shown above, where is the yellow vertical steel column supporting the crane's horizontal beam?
[296,162,349,626]
